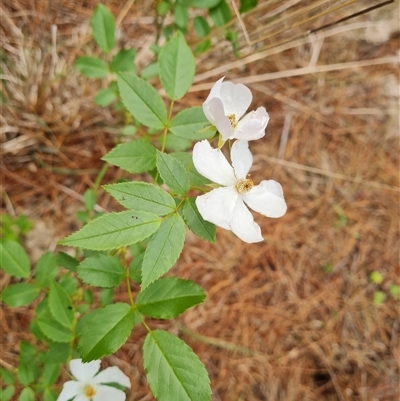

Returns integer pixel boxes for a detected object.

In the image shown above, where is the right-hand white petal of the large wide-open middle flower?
[243,180,287,217]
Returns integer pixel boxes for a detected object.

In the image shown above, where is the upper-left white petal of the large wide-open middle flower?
[193,140,236,186]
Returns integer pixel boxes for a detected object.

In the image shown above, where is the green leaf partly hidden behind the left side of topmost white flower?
[169,107,215,141]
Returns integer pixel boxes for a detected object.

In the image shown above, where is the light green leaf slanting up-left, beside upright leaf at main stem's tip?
[118,72,168,129]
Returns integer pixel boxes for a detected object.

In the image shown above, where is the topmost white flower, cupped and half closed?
[203,78,269,141]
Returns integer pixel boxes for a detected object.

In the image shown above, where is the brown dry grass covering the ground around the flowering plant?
[1,0,400,401]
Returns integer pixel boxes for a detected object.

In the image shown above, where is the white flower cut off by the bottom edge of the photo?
[57,359,131,401]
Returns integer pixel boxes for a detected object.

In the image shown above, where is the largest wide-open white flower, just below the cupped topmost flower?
[193,140,287,243]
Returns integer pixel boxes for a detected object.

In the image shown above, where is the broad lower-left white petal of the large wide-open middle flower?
[196,187,239,230]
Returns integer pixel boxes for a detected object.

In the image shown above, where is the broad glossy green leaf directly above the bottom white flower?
[78,302,135,362]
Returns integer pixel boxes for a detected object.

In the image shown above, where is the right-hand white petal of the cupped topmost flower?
[233,107,269,141]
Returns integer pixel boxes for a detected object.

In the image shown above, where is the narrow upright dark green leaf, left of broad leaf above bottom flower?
[49,281,75,328]
